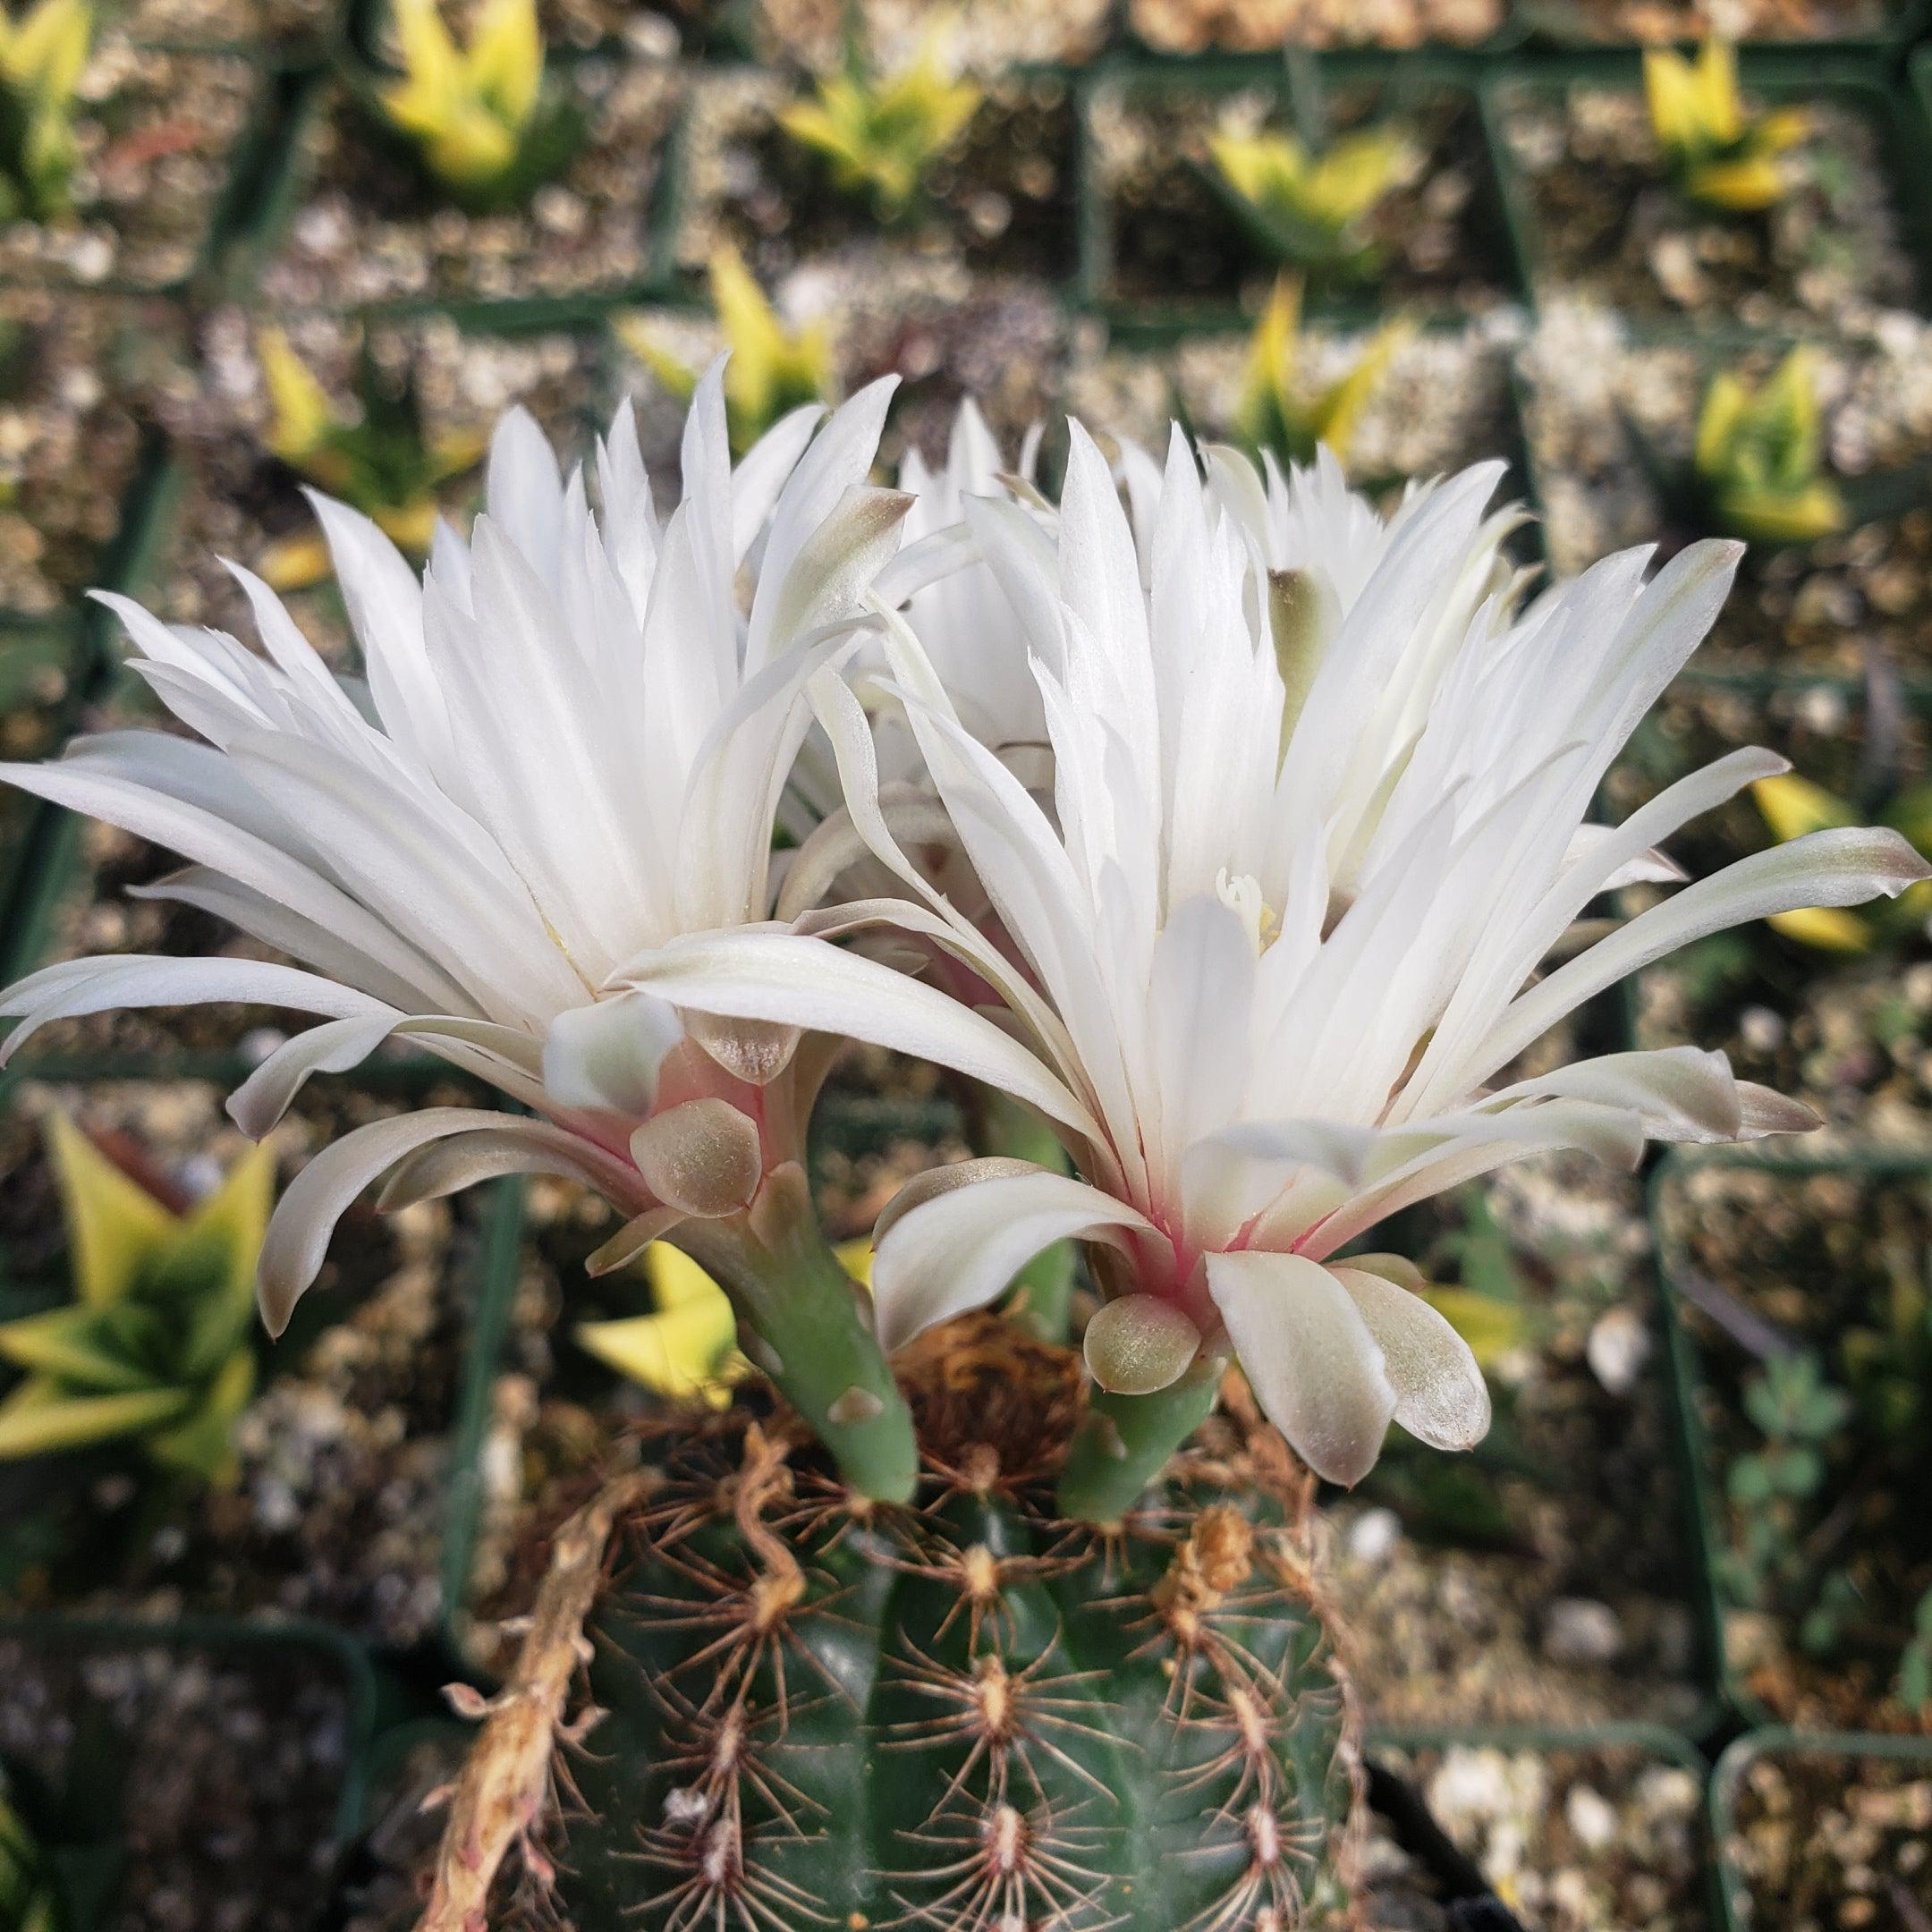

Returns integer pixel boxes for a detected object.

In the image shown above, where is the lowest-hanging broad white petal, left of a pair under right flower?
[1208,1248,1395,1486]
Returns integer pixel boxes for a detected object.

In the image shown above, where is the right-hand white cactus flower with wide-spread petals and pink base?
[620,425,1927,1482]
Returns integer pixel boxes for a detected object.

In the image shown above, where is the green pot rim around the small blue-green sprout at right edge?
[1648,1148,1932,1729]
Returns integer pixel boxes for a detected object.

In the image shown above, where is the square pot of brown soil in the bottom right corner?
[1710,1729,1932,1932]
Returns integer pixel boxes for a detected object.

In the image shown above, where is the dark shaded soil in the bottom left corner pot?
[0,1632,355,1932]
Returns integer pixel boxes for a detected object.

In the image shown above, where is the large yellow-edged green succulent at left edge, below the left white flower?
[0,1113,275,1482]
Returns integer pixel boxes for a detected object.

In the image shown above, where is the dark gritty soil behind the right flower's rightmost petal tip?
[1606,676,1932,1146]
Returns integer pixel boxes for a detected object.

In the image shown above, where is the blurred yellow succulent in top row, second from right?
[1209,128,1422,273]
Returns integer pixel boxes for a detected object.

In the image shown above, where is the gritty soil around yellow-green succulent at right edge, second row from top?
[1519,317,1932,684]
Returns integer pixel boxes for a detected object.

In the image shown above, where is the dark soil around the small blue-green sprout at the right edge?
[1662,1163,1932,1729]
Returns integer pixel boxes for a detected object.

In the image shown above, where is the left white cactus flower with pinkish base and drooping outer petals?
[0,363,906,1329]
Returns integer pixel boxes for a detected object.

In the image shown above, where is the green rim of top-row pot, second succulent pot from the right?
[1076,50,1521,342]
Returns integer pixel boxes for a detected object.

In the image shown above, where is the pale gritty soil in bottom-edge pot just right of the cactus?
[1364,1744,1710,1932]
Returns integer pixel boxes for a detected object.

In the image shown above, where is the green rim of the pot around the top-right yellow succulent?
[1480,47,1932,324]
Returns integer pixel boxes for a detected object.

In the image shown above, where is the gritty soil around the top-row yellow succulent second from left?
[251,48,680,318]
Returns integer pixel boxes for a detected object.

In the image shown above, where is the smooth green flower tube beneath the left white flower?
[676,1165,918,1503]
